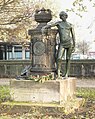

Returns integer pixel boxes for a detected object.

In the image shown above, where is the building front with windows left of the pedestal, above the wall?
[0,44,30,60]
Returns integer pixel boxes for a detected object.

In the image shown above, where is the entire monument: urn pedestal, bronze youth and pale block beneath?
[10,8,81,109]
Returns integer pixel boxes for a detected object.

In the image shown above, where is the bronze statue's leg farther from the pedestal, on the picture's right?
[65,48,72,78]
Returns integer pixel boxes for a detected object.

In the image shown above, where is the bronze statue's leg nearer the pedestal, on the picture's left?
[57,46,64,78]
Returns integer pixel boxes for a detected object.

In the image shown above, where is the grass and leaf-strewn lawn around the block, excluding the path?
[0,86,95,119]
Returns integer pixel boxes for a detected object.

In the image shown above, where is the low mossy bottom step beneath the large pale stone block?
[0,98,85,116]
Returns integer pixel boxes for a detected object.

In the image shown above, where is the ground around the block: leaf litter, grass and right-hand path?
[0,79,95,119]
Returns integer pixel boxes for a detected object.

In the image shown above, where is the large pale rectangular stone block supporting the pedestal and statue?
[10,78,76,104]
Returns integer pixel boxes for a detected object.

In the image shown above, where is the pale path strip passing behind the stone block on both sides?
[0,78,95,88]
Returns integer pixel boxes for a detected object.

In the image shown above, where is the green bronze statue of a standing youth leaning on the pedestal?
[42,11,75,78]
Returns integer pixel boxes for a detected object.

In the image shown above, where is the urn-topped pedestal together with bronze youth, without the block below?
[17,8,75,79]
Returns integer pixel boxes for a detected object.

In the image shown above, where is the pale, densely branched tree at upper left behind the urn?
[0,0,57,42]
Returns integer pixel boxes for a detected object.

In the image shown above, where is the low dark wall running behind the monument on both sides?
[0,60,95,78]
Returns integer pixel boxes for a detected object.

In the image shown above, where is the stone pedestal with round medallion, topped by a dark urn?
[28,8,58,76]
